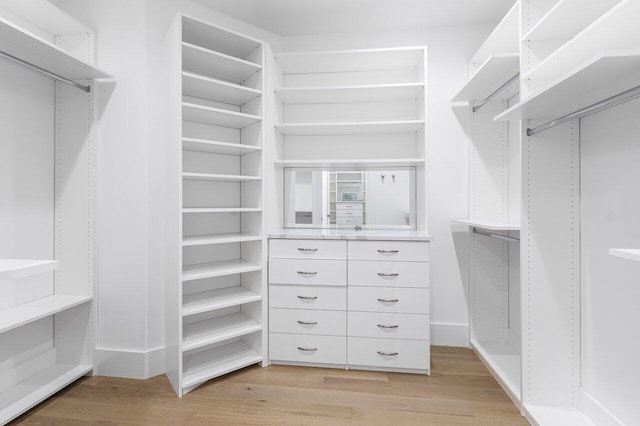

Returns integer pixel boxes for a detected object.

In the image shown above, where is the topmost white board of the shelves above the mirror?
[276,47,425,74]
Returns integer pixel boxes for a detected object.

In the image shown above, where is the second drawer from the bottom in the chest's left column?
[269,308,347,337]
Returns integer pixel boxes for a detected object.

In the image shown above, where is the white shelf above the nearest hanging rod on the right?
[495,50,640,121]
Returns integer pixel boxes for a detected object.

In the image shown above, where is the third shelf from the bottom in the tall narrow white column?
[182,287,262,317]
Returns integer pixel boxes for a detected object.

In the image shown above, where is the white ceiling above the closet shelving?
[195,0,515,36]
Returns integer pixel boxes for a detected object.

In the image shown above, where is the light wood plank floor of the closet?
[12,347,528,426]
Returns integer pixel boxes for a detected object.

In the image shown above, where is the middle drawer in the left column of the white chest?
[269,284,347,311]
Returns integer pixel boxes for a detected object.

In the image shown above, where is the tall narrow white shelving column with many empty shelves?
[166,16,266,396]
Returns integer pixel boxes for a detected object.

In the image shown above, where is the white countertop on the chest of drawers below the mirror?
[269,228,433,241]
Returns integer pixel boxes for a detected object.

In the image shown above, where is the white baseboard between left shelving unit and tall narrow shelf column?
[93,347,165,379]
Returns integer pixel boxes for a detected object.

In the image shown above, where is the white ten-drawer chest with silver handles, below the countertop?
[269,233,430,374]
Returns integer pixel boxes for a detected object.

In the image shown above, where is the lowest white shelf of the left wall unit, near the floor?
[0,364,92,424]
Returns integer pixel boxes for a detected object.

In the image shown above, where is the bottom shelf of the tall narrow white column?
[182,342,262,389]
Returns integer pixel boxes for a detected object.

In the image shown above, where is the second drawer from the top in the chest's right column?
[349,260,429,288]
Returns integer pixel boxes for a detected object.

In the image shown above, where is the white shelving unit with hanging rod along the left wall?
[0,0,111,424]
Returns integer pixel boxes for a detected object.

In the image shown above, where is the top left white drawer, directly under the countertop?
[269,239,347,259]
